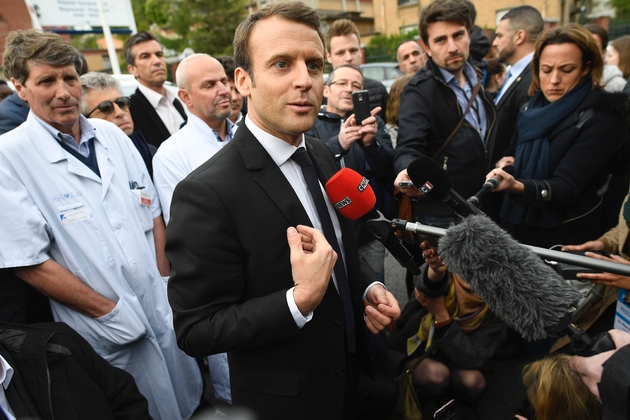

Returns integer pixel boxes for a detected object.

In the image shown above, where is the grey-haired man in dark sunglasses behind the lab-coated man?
[81,71,157,176]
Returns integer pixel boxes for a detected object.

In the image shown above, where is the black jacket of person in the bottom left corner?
[0,322,151,420]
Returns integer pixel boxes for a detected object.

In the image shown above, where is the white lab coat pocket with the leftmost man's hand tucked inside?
[96,297,147,354]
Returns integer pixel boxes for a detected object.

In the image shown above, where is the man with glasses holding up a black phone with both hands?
[306,64,394,281]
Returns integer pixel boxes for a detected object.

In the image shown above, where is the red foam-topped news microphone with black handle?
[325,168,420,275]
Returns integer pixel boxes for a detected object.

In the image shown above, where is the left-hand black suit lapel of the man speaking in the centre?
[232,124,313,230]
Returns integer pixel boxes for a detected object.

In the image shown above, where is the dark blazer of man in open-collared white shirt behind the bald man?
[130,89,188,147]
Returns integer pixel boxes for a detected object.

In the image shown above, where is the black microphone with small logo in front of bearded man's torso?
[407,155,483,217]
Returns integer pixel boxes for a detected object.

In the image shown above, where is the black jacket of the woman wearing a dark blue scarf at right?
[505,89,630,248]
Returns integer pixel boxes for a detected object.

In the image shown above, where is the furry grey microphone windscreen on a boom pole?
[438,215,582,340]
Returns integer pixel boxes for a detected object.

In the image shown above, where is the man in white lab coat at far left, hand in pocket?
[0,31,201,420]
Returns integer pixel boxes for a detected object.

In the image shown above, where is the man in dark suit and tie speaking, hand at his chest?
[167,2,400,420]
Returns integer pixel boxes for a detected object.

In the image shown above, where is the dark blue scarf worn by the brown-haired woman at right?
[501,75,591,228]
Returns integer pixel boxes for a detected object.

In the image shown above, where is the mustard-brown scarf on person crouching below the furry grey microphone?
[407,274,488,355]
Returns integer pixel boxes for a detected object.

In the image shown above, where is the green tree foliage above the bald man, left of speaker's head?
[137,0,246,55]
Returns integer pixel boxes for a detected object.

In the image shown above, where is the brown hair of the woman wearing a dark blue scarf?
[528,23,604,96]
